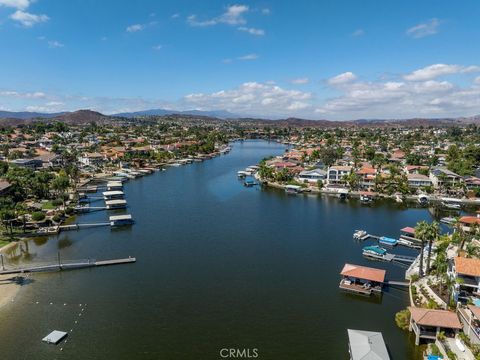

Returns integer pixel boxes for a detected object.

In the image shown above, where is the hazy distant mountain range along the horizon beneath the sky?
[0,109,480,128]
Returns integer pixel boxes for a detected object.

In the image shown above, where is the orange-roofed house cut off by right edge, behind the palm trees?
[447,256,480,302]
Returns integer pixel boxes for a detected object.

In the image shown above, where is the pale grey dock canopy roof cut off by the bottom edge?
[347,329,390,360]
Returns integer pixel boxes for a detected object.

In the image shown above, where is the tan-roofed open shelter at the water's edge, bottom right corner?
[408,306,462,345]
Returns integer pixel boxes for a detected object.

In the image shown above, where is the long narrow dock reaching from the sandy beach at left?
[0,257,137,275]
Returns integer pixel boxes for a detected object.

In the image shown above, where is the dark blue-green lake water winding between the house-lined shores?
[0,141,431,360]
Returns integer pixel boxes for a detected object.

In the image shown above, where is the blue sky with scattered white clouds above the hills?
[0,0,480,120]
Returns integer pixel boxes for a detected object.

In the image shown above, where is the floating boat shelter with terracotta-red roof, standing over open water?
[339,264,386,295]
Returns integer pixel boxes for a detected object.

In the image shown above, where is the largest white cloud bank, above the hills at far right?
[315,64,480,119]
